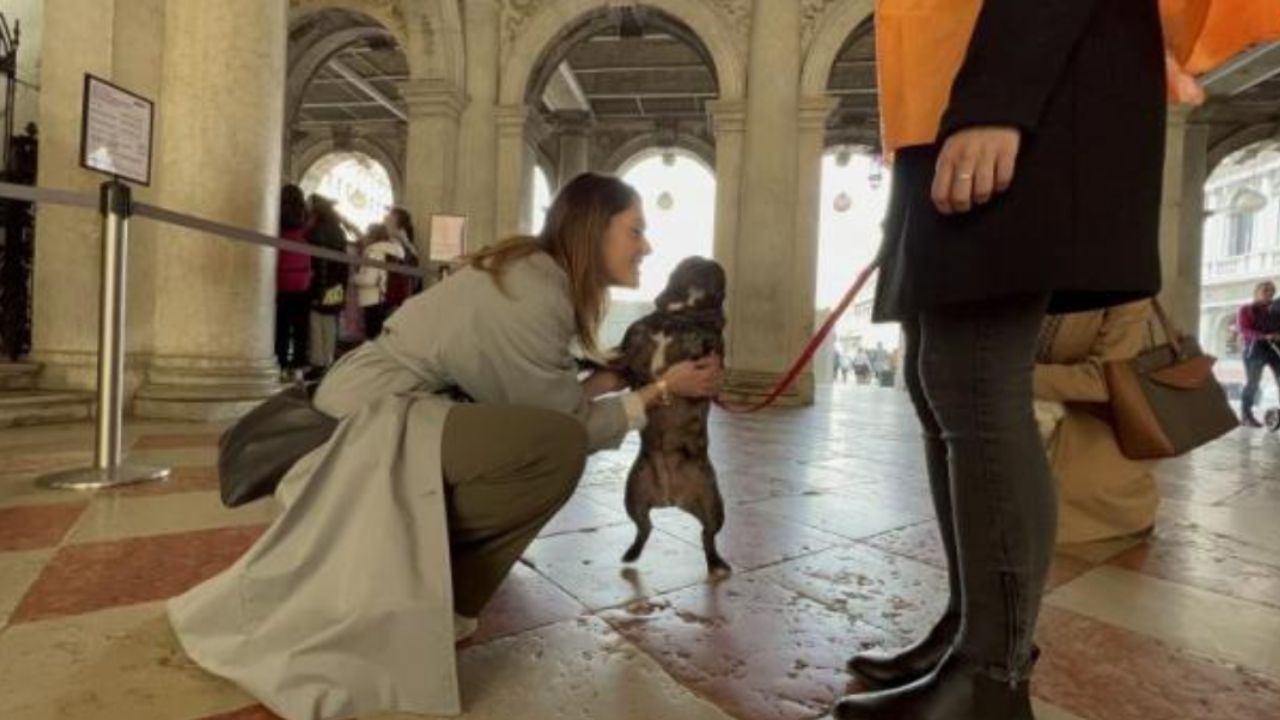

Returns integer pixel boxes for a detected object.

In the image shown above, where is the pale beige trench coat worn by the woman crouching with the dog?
[169,255,628,720]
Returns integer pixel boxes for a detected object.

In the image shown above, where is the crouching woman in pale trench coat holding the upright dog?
[169,174,723,720]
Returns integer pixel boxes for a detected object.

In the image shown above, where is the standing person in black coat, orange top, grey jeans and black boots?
[833,0,1166,720]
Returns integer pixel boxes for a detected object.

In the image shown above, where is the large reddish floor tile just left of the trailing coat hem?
[11,525,265,622]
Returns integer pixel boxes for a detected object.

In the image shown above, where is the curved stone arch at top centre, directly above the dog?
[498,0,746,106]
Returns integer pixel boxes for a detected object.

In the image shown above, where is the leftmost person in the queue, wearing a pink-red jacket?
[275,184,311,377]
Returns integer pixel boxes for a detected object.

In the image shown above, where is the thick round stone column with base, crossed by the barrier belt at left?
[134,0,288,420]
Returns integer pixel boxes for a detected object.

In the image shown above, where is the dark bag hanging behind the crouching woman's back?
[218,383,338,507]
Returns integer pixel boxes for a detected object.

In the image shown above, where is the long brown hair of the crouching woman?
[467,173,640,355]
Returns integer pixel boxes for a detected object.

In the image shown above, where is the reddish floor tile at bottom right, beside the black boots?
[1033,606,1280,720]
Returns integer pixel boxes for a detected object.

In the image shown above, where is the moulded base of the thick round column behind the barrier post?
[133,359,280,423]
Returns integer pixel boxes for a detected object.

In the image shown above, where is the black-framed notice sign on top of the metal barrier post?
[81,74,155,184]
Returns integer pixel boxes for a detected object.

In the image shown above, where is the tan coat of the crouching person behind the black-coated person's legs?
[1034,301,1160,543]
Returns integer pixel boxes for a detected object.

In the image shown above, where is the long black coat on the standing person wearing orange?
[876,0,1166,320]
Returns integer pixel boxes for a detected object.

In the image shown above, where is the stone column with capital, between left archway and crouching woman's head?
[401,79,467,258]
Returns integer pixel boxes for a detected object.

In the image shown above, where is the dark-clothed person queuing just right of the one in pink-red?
[307,195,349,375]
